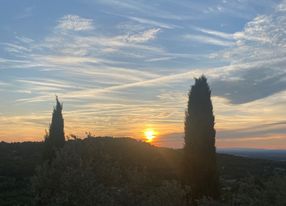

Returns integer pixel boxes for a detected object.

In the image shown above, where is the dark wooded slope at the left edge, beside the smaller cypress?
[0,142,43,206]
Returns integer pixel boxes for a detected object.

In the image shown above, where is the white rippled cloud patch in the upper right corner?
[222,1,286,62]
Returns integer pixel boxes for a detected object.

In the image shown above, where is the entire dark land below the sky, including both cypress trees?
[0,76,286,206]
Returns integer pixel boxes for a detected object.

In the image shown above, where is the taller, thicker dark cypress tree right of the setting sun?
[184,76,219,199]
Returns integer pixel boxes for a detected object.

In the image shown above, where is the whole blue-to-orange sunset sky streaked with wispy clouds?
[0,0,286,149]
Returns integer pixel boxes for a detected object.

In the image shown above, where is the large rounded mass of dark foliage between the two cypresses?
[33,137,185,206]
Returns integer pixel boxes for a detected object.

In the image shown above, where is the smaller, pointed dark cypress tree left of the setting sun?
[43,97,65,160]
